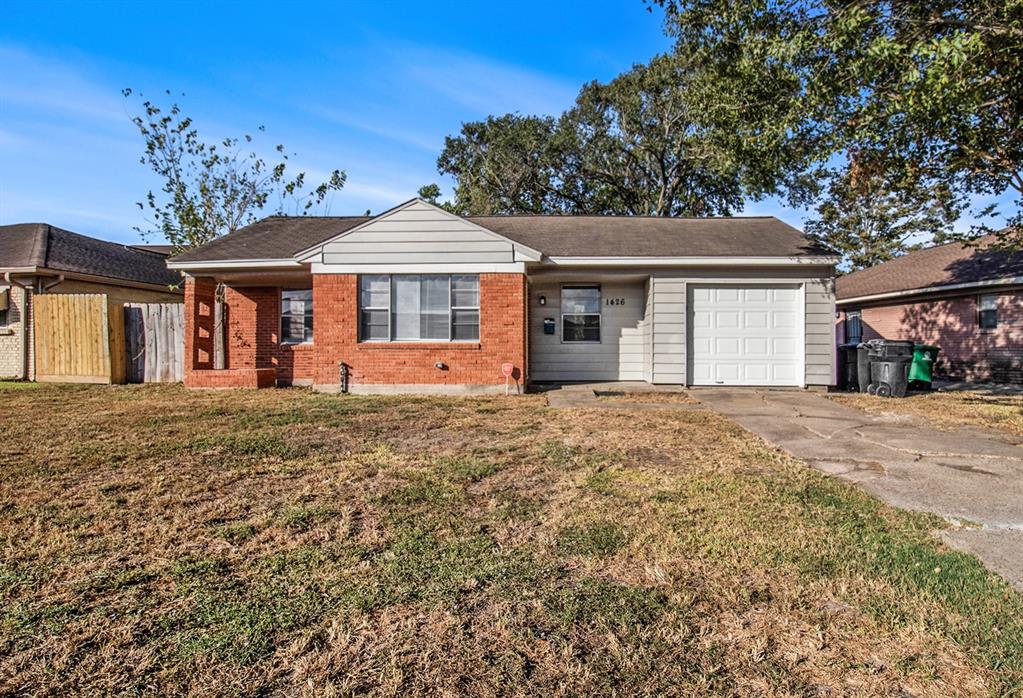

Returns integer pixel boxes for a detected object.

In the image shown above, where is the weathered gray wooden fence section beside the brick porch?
[125,303,185,383]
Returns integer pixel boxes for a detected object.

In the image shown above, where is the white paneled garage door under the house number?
[688,285,803,386]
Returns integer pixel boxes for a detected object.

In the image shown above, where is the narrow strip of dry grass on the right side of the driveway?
[830,391,1023,436]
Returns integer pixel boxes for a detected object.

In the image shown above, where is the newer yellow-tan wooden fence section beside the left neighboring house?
[32,294,125,383]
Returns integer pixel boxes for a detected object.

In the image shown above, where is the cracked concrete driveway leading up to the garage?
[692,388,1023,590]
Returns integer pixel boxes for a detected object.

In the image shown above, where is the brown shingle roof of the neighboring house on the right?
[836,236,1023,301]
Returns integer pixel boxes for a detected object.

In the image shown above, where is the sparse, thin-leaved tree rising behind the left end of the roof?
[124,89,345,250]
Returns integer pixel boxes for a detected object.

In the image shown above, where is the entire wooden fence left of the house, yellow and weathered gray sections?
[32,294,185,383]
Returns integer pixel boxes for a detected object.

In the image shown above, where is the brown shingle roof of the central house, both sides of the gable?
[174,210,832,262]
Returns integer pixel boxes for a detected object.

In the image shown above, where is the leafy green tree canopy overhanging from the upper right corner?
[660,0,1023,245]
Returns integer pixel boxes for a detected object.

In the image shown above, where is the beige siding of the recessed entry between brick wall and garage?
[529,279,647,382]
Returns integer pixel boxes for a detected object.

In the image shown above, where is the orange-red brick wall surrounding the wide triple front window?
[313,273,527,386]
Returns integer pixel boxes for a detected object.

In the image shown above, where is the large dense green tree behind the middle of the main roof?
[438,54,815,216]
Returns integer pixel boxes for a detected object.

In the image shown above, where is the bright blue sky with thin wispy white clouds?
[0,0,1006,242]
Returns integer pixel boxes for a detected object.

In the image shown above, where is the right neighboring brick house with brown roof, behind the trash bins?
[837,237,1023,382]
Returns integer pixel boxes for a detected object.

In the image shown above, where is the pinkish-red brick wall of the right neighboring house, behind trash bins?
[847,291,1023,382]
